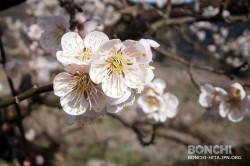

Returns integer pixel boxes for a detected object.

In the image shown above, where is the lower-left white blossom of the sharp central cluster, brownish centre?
[53,64,106,116]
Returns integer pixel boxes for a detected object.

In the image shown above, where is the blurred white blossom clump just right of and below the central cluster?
[137,78,179,123]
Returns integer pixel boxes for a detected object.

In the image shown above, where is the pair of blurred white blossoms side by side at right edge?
[199,83,250,122]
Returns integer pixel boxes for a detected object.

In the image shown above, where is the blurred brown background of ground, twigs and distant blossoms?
[0,0,250,166]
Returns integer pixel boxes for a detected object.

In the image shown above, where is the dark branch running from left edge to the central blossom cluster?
[0,84,53,108]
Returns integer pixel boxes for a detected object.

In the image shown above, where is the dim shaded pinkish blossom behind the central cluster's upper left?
[38,16,70,54]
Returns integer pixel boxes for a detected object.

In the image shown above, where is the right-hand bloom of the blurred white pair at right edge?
[219,83,250,122]
